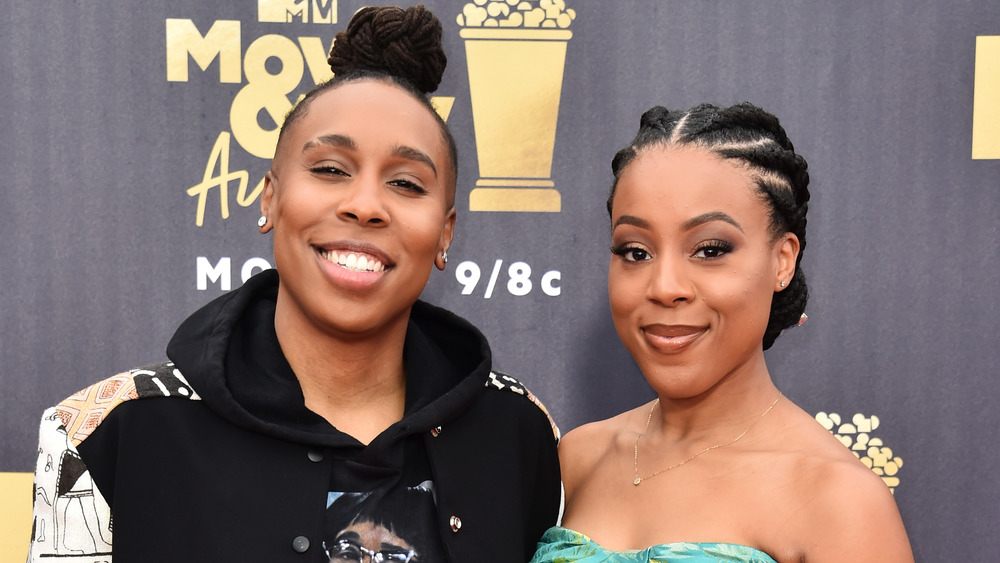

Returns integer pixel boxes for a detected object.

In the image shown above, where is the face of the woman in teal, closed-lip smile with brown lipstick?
[608,145,798,398]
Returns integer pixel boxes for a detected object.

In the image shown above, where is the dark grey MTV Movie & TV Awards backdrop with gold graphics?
[0,0,1000,562]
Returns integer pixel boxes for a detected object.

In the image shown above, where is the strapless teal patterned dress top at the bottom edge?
[531,526,777,563]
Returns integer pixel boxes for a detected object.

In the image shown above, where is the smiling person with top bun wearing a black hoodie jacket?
[29,6,561,563]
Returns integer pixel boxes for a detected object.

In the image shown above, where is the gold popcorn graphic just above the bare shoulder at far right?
[815,412,903,494]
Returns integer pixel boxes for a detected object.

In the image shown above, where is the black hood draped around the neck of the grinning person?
[167,270,492,447]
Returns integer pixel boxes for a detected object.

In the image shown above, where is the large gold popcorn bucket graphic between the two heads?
[457,0,576,212]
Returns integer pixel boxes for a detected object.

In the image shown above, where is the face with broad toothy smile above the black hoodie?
[261,80,455,337]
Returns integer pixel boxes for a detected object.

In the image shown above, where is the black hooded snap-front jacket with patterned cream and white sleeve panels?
[31,272,561,563]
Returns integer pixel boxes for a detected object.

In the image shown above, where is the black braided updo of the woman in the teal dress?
[607,102,809,350]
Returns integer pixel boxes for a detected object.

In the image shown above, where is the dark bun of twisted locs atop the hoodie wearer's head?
[327,4,448,94]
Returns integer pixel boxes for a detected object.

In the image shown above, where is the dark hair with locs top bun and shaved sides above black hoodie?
[278,4,458,194]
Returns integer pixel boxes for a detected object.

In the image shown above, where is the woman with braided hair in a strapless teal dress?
[532,103,913,563]
